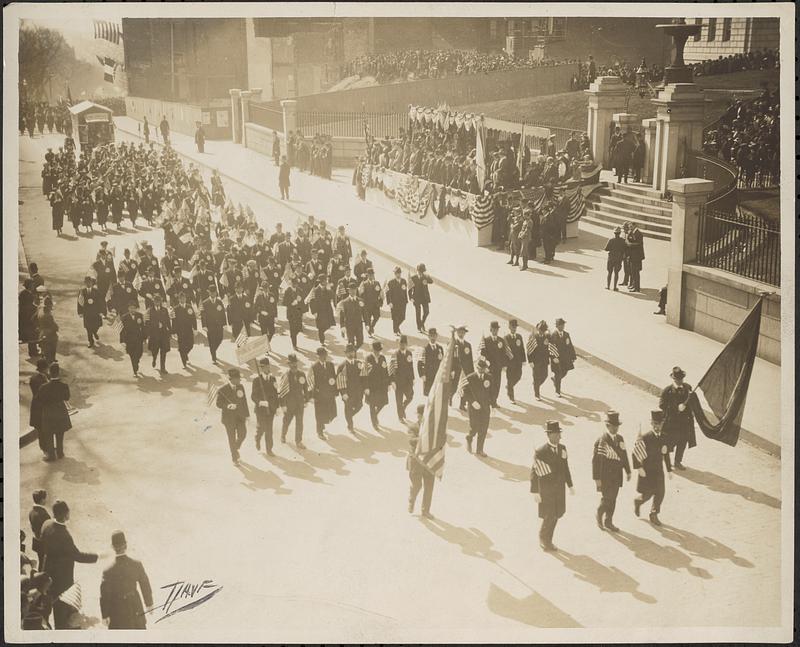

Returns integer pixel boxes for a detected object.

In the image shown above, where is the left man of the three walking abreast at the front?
[531,420,575,551]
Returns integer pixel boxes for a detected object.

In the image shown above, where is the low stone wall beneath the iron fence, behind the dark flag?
[681,264,781,365]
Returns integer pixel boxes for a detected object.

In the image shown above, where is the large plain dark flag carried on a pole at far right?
[689,295,764,447]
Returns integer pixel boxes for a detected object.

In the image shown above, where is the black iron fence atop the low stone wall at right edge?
[695,207,781,286]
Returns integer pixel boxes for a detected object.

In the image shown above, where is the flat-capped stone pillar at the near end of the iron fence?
[667,177,714,328]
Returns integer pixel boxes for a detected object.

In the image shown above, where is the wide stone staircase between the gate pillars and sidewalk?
[581,182,672,240]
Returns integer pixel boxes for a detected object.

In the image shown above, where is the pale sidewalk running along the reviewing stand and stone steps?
[115,117,781,455]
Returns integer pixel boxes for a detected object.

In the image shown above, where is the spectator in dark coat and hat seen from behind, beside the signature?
[100,530,153,629]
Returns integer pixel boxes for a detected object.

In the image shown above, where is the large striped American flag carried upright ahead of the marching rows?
[415,331,455,479]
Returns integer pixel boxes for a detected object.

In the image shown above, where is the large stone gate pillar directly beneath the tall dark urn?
[652,83,705,194]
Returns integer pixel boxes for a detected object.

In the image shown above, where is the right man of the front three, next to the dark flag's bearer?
[633,409,672,526]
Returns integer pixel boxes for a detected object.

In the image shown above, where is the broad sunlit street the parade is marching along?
[20,130,781,642]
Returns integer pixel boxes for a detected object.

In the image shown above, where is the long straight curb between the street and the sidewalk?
[117,119,781,459]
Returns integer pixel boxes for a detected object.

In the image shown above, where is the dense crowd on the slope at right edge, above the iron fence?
[703,89,780,188]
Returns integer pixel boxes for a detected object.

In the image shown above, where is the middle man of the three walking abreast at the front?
[592,411,631,532]
